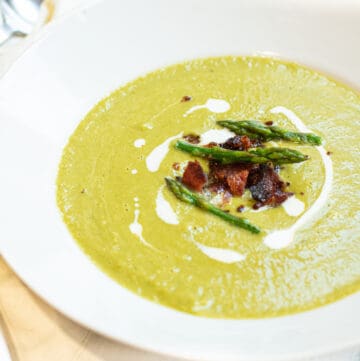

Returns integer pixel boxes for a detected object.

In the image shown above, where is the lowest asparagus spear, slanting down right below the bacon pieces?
[165,177,261,233]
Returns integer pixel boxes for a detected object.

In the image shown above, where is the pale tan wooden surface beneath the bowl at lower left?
[0,258,179,361]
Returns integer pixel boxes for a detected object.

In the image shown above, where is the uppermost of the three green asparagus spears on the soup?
[217,120,322,145]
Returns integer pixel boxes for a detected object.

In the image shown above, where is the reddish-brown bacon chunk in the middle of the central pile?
[209,161,252,196]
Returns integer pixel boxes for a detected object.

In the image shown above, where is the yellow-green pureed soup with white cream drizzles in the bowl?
[57,57,360,318]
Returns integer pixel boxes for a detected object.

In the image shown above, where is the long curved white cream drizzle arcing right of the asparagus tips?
[264,106,333,249]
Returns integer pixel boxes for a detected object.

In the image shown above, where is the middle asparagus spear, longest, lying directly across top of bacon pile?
[175,140,309,164]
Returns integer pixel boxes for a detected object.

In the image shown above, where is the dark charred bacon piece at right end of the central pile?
[247,164,293,209]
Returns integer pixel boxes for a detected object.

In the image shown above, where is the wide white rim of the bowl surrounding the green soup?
[0,0,360,361]
